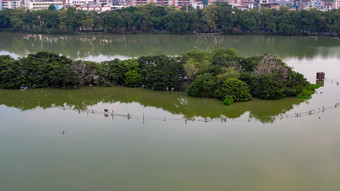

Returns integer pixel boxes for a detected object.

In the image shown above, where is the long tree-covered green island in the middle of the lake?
[0,48,318,105]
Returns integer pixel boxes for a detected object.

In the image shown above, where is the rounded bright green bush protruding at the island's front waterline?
[217,78,251,102]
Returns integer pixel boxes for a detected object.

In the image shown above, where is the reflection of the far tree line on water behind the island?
[0,33,340,59]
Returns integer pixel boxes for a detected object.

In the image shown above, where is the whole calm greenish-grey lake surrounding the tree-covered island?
[0,33,340,191]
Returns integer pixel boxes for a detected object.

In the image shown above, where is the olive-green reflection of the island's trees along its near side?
[0,87,303,123]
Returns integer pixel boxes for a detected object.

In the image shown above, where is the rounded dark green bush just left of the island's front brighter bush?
[188,73,218,97]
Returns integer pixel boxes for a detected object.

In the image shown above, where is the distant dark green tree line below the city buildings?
[0,3,340,35]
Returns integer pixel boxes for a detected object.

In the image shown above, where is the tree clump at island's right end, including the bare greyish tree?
[240,54,309,99]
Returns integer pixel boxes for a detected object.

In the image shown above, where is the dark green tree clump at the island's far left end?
[1,52,78,89]
